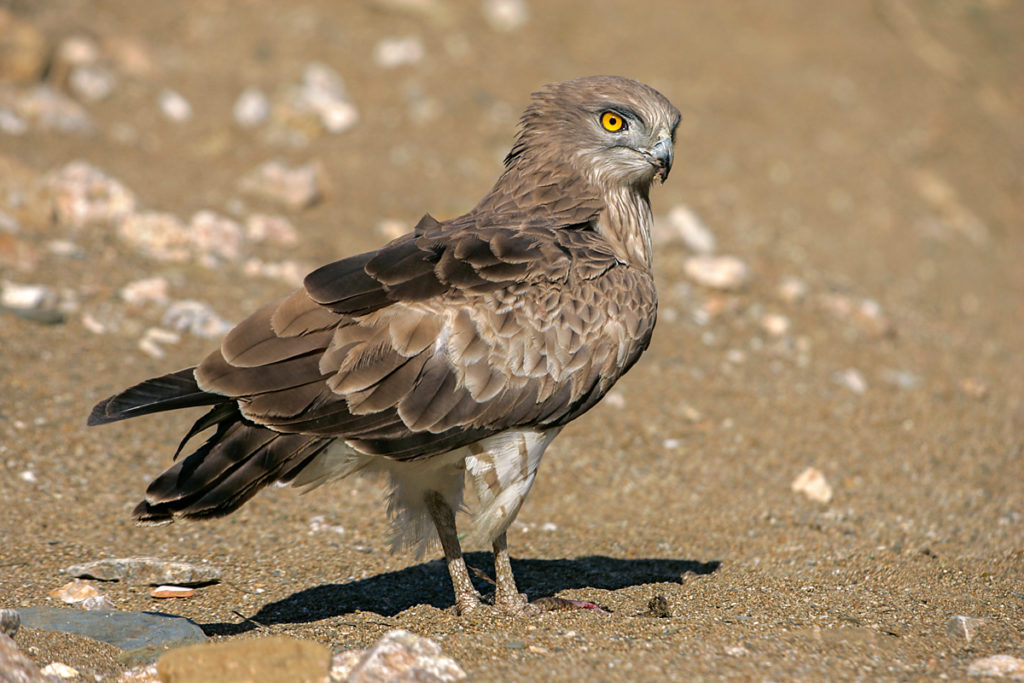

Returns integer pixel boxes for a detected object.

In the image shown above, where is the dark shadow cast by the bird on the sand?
[201,553,721,636]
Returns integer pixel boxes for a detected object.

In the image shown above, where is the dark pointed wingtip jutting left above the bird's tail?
[88,368,230,426]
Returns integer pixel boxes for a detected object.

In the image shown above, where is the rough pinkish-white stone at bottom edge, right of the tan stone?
[348,629,466,683]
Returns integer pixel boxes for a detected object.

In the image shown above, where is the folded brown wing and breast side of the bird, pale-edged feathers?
[196,223,656,460]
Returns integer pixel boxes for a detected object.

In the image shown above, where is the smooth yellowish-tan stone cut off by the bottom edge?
[157,636,329,682]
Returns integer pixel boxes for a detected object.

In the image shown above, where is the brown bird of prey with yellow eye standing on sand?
[89,76,679,613]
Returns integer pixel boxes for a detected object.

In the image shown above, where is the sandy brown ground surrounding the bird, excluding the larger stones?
[0,0,1024,680]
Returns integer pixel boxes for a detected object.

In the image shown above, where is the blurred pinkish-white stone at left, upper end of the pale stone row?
[44,161,135,228]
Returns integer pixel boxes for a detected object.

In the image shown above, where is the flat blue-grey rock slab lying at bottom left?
[17,607,207,664]
